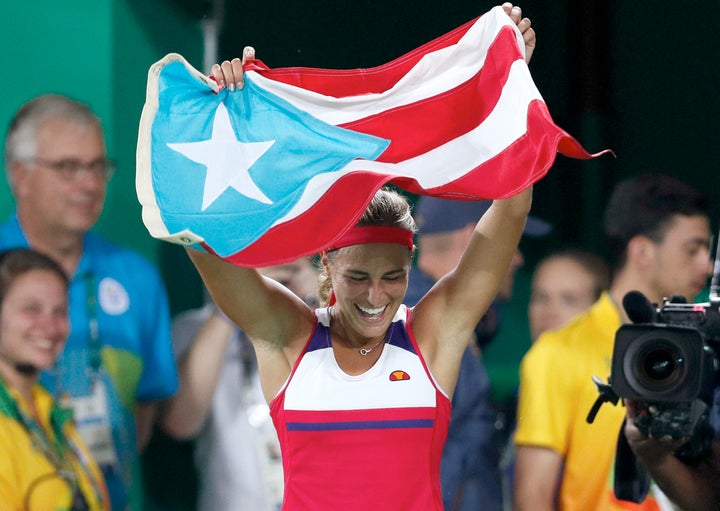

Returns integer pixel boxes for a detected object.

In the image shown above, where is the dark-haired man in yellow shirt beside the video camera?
[514,174,712,511]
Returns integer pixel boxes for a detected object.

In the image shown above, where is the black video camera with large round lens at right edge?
[609,293,720,461]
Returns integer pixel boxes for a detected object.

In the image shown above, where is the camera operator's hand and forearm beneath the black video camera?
[624,399,720,511]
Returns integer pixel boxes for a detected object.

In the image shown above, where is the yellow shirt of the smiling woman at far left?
[0,380,110,511]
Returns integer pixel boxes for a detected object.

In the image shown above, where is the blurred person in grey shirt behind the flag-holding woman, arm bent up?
[161,258,318,511]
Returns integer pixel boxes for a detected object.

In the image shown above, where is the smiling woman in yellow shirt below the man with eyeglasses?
[0,249,110,511]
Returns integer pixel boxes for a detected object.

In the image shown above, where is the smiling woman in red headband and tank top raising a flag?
[188,4,535,511]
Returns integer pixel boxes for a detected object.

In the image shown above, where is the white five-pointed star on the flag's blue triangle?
[168,103,275,211]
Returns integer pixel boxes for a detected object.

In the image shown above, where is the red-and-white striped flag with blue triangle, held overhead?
[136,7,595,266]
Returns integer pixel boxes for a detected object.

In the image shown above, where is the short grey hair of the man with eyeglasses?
[5,94,102,172]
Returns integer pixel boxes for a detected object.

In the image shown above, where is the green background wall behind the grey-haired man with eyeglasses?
[0,0,203,311]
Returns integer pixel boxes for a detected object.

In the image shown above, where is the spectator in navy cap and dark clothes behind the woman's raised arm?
[405,197,550,511]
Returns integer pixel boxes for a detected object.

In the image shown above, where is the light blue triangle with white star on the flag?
[151,62,389,257]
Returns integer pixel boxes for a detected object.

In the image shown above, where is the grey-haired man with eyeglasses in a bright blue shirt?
[0,94,177,510]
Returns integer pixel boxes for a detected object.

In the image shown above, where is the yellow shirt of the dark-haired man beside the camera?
[515,293,625,511]
